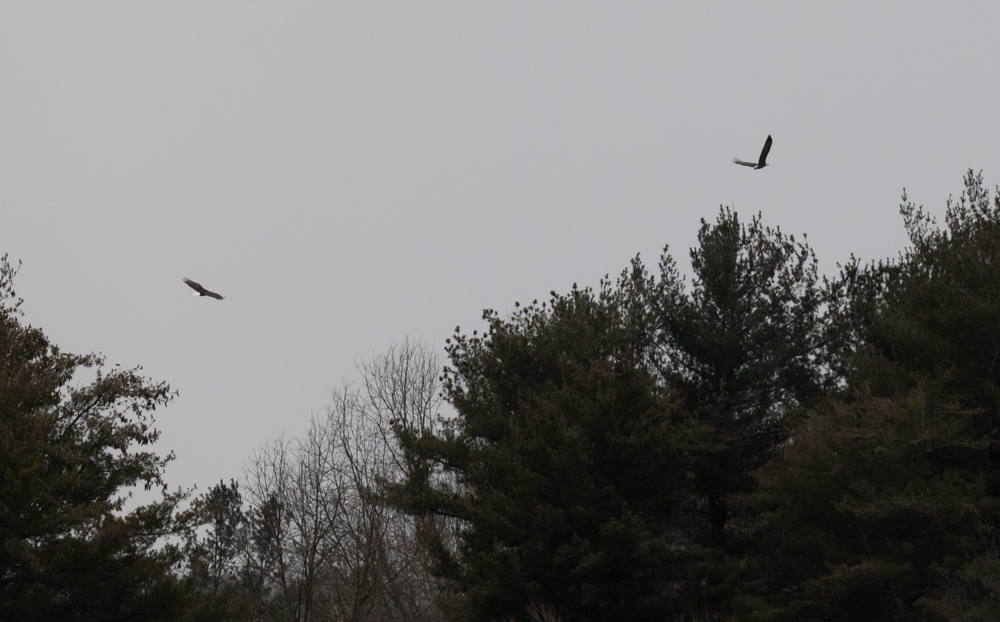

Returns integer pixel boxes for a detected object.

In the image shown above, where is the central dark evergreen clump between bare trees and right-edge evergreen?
[396,210,829,620]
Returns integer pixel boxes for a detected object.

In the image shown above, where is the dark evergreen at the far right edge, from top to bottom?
[744,171,1000,620]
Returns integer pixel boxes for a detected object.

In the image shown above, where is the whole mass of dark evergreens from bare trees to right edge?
[390,172,1000,620]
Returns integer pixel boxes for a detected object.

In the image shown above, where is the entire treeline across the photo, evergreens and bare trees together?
[0,171,1000,622]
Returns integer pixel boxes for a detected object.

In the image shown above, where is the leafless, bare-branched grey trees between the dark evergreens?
[229,340,451,622]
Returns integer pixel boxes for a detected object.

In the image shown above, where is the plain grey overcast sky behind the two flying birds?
[0,0,1000,488]
